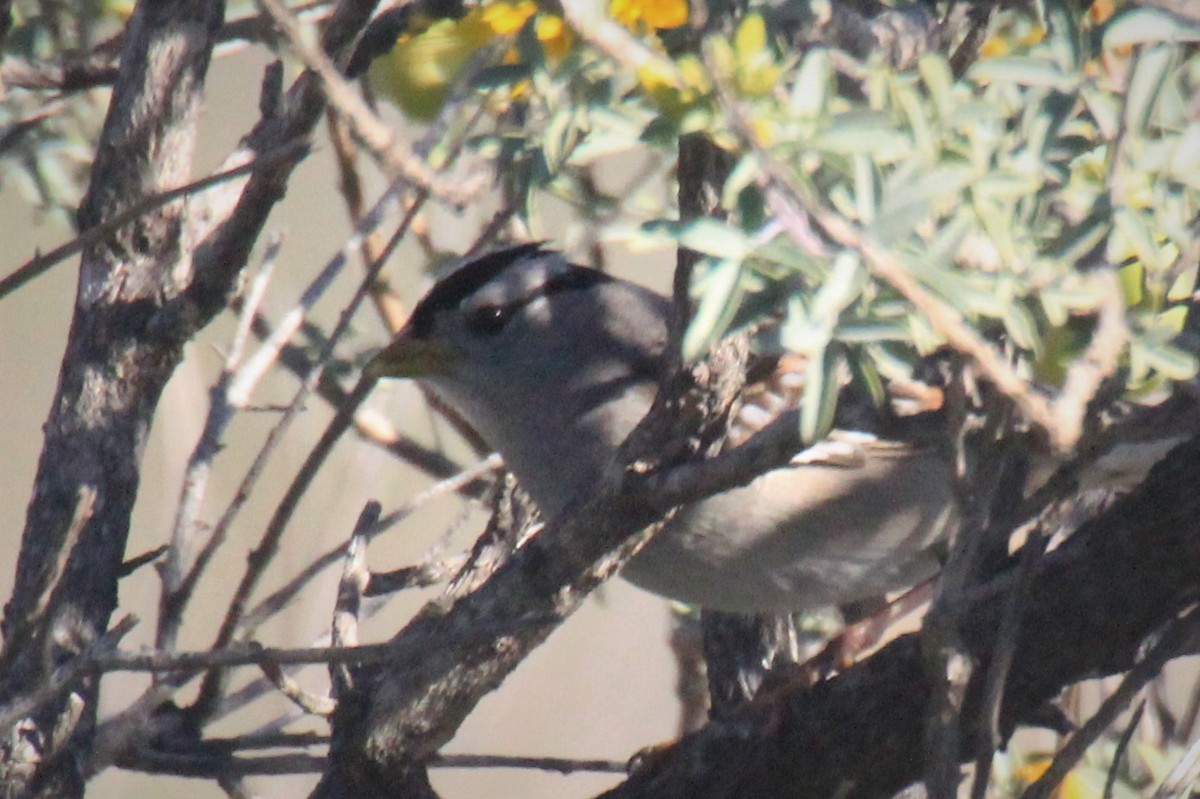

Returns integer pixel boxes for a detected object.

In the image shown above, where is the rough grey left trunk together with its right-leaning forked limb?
[0,0,374,797]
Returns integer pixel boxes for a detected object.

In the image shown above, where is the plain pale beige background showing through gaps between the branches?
[0,44,678,799]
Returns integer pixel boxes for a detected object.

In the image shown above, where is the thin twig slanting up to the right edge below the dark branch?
[1021,606,1200,799]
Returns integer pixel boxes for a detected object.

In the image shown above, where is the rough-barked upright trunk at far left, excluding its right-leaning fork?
[0,0,224,797]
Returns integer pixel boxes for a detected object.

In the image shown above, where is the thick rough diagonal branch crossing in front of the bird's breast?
[318,335,752,797]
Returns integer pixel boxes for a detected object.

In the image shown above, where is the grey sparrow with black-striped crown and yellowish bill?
[367,245,954,612]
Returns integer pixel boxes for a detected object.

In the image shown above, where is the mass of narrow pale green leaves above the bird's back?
[362,0,1200,435]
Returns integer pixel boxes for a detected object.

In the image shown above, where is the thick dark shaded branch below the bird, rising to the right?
[606,439,1200,799]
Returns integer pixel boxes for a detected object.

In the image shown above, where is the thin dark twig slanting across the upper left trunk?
[0,142,308,300]
